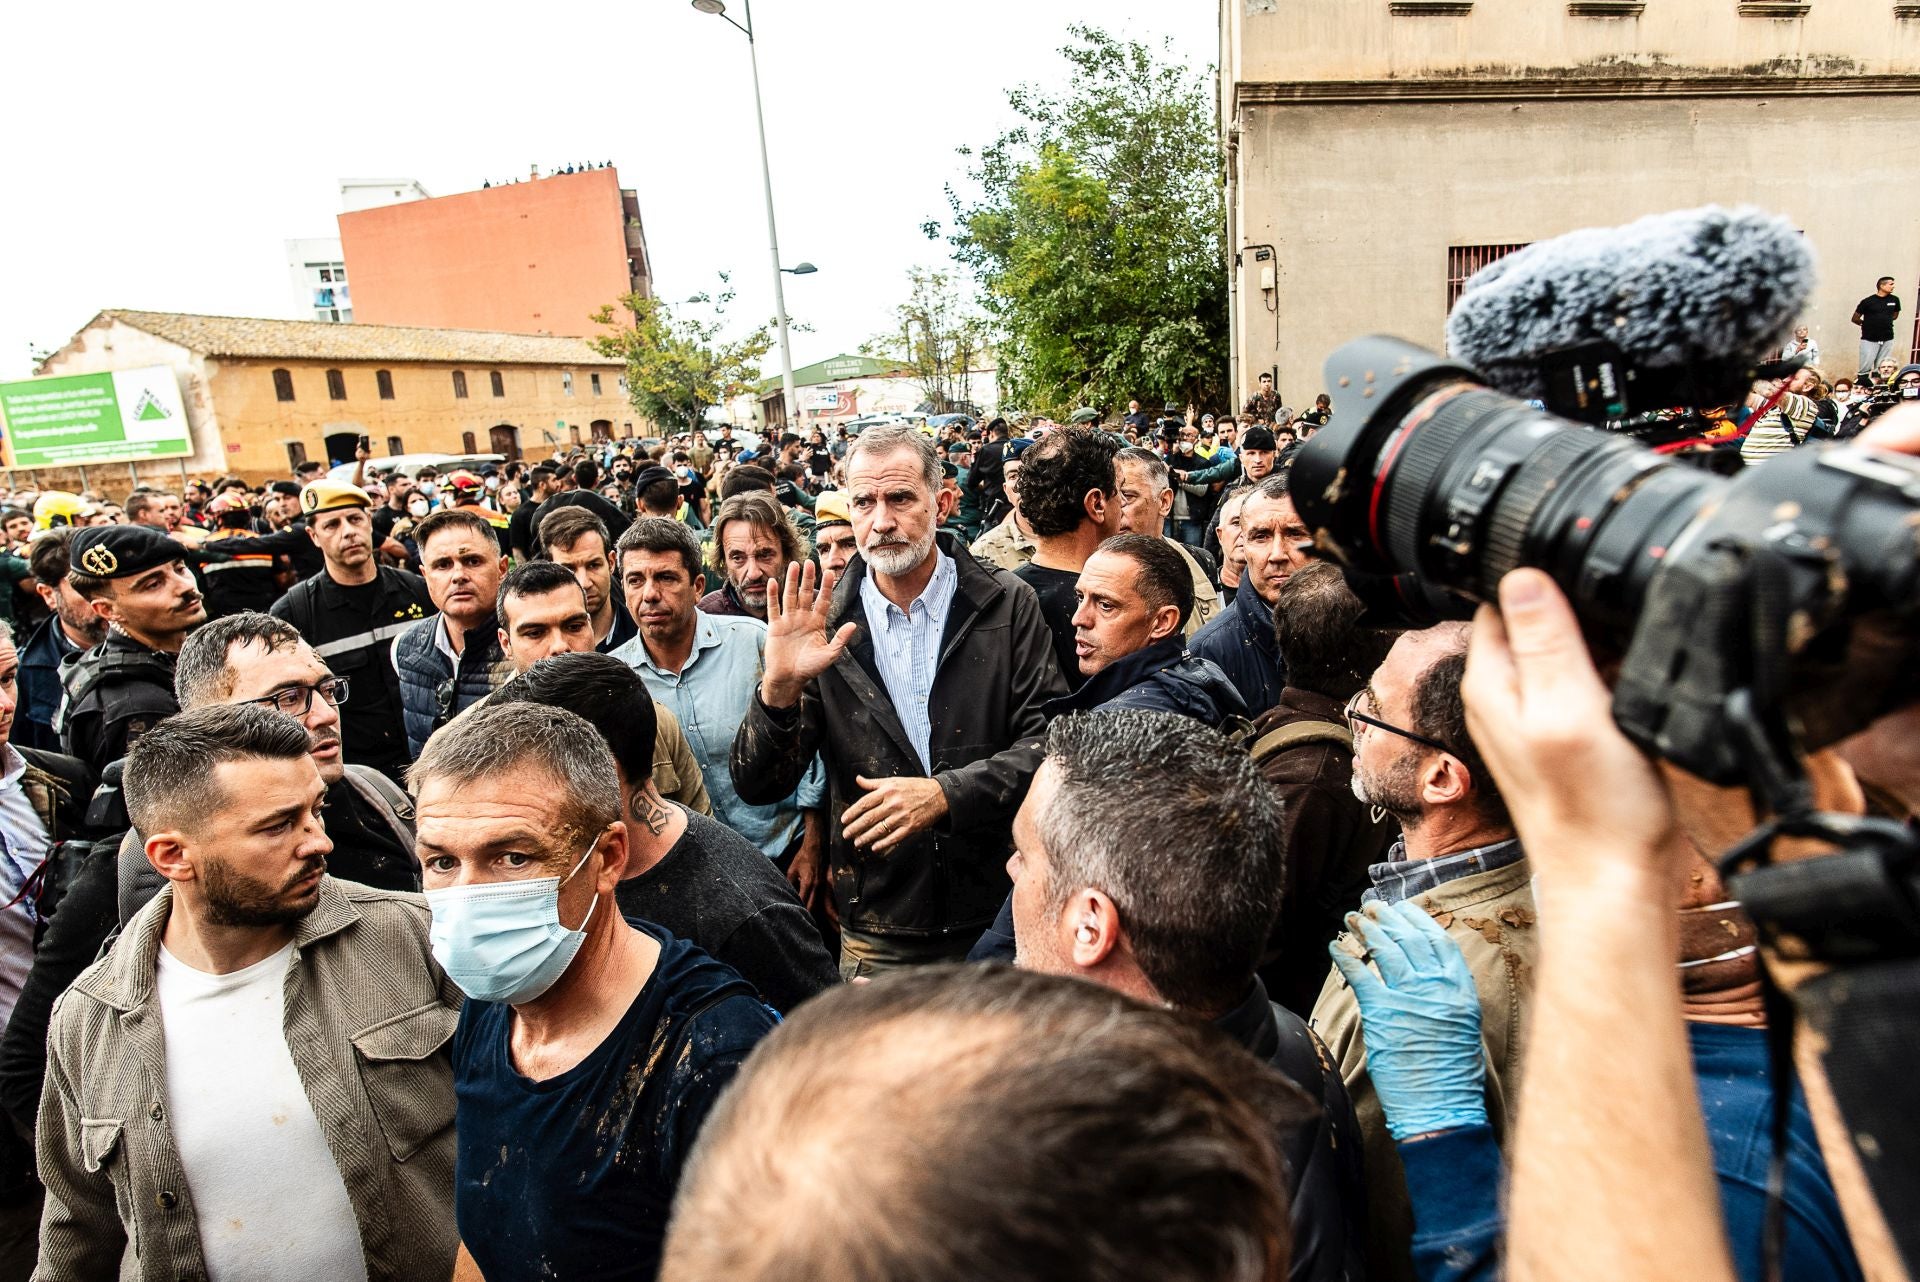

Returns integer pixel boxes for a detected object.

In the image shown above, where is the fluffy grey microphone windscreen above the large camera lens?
[1446,205,1814,397]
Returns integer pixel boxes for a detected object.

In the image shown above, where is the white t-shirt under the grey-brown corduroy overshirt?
[154,942,367,1282]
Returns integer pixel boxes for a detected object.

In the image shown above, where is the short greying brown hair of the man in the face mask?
[408,702,620,841]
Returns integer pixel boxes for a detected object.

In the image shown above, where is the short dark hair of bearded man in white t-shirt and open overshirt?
[123,702,311,835]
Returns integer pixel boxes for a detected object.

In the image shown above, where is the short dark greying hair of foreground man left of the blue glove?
[1037,710,1284,1017]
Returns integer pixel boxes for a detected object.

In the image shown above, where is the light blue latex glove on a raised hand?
[1329,900,1486,1140]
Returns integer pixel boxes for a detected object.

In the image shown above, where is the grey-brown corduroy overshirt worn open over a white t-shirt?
[35,877,462,1282]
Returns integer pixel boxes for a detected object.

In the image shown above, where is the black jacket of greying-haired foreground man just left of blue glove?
[1213,979,1367,1282]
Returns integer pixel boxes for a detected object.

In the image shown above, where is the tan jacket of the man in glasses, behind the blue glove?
[1311,858,1540,1282]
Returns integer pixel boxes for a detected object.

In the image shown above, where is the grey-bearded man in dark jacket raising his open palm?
[732,426,1066,977]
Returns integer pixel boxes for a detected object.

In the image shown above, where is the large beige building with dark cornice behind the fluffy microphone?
[1219,0,1920,407]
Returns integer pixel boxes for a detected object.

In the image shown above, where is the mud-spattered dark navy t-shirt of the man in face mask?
[453,921,778,1282]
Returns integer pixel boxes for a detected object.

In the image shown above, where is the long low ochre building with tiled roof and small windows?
[35,311,636,489]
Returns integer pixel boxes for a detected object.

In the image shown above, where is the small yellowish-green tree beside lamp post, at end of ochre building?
[588,273,774,432]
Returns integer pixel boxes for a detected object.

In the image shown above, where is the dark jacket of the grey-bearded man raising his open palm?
[733,537,1066,940]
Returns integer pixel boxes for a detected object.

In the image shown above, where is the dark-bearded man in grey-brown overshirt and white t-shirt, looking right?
[35,704,463,1282]
